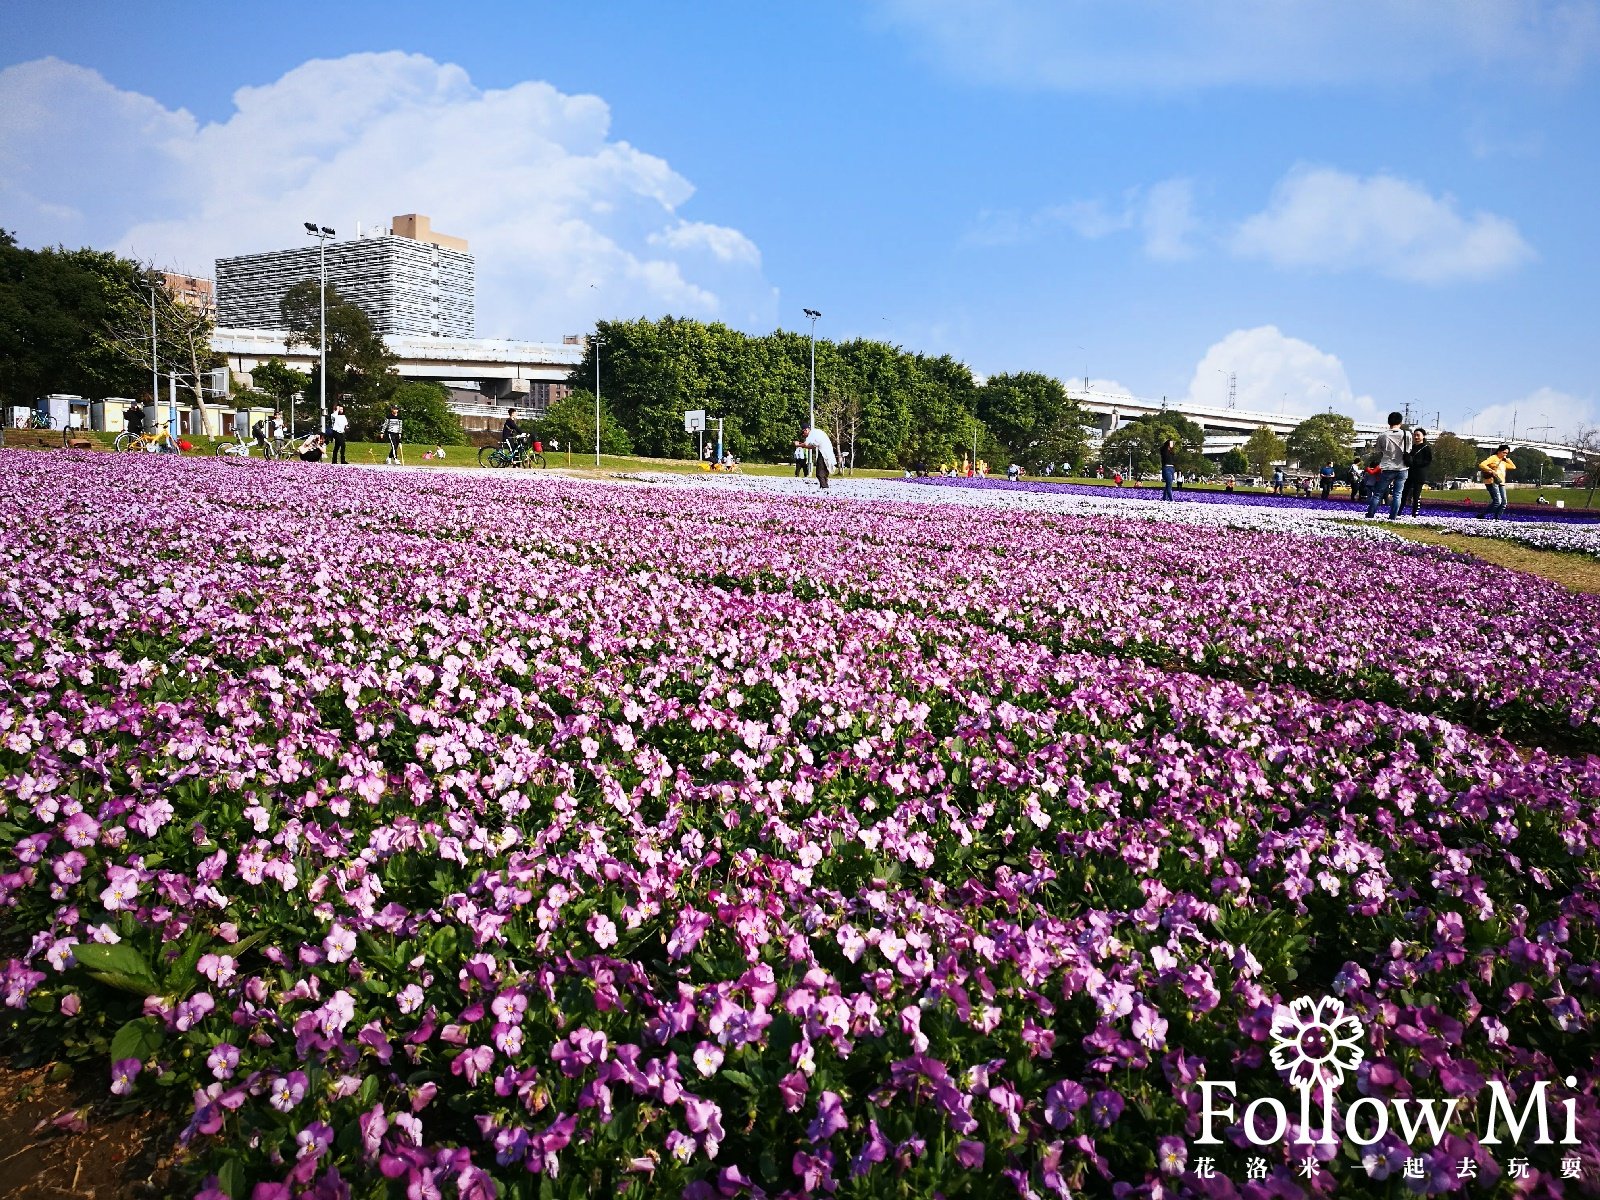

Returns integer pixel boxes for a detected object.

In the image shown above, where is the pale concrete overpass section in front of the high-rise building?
[211,328,584,403]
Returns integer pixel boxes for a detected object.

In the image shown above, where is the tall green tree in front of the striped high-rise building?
[278,278,395,442]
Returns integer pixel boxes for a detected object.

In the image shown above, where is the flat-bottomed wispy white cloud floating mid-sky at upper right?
[1229,166,1533,283]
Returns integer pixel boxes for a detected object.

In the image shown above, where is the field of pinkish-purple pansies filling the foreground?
[0,451,1600,1200]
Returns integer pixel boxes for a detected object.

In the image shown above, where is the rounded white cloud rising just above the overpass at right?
[1189,325,1381,421]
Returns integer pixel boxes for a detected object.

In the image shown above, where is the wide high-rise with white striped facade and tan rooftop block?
[216,213,477,338]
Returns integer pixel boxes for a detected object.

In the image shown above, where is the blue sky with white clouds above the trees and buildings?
[0,0,1600,435]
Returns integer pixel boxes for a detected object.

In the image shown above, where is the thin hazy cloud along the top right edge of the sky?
[877,0,1600,93]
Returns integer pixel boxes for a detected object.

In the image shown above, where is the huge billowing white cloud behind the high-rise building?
[0,53,776,339]
